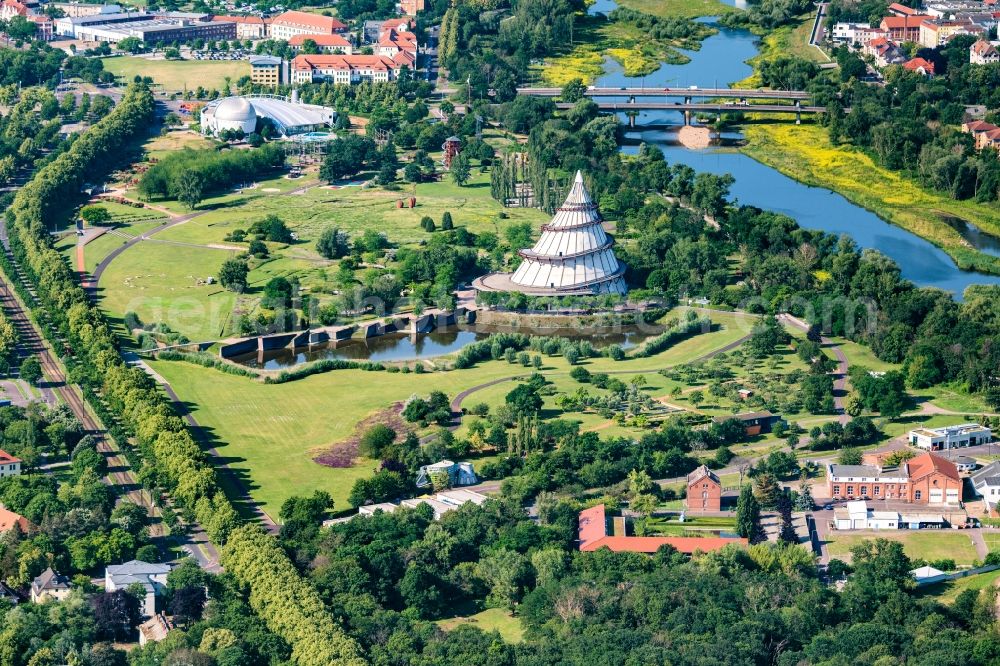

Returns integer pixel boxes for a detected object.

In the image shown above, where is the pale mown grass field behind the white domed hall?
[104,56,250,92]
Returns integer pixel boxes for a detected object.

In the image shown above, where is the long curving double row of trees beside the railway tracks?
[8,84,364,666]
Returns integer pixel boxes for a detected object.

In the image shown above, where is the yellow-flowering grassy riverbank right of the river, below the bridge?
[742,122,1000,274]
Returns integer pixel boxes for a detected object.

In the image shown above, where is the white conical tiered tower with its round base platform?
[473,171,628,296]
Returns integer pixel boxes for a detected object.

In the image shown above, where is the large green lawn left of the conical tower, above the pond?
[96,173,548,340]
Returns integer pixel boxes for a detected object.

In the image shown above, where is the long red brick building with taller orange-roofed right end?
[826,453,962,505]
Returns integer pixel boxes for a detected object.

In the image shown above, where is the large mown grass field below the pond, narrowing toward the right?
[151,308,744,516]
